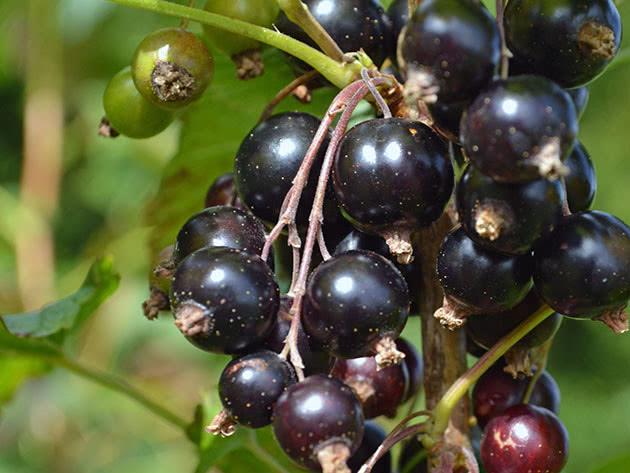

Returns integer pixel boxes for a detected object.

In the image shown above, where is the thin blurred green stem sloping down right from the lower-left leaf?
[57,357,188,430]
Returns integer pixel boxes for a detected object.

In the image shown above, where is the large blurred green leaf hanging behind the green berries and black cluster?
[146,49,337,255]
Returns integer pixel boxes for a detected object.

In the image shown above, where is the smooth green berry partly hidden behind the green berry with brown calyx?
[103,67,175,138]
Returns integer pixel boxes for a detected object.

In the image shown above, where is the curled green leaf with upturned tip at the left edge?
[0,257,120,343]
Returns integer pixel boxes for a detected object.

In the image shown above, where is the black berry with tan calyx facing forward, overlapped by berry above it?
[456,165,565,254]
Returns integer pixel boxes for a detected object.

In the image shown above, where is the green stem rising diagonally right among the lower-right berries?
[423,306,553,442]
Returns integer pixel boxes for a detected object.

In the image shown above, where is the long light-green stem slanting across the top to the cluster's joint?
[107,0,362,88]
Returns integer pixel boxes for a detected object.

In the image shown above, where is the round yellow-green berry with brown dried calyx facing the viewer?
[131,28,214,110]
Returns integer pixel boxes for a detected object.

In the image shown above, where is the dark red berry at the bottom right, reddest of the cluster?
[481,404,569,473]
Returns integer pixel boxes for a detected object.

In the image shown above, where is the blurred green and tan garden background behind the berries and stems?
[0,0,630,473]
